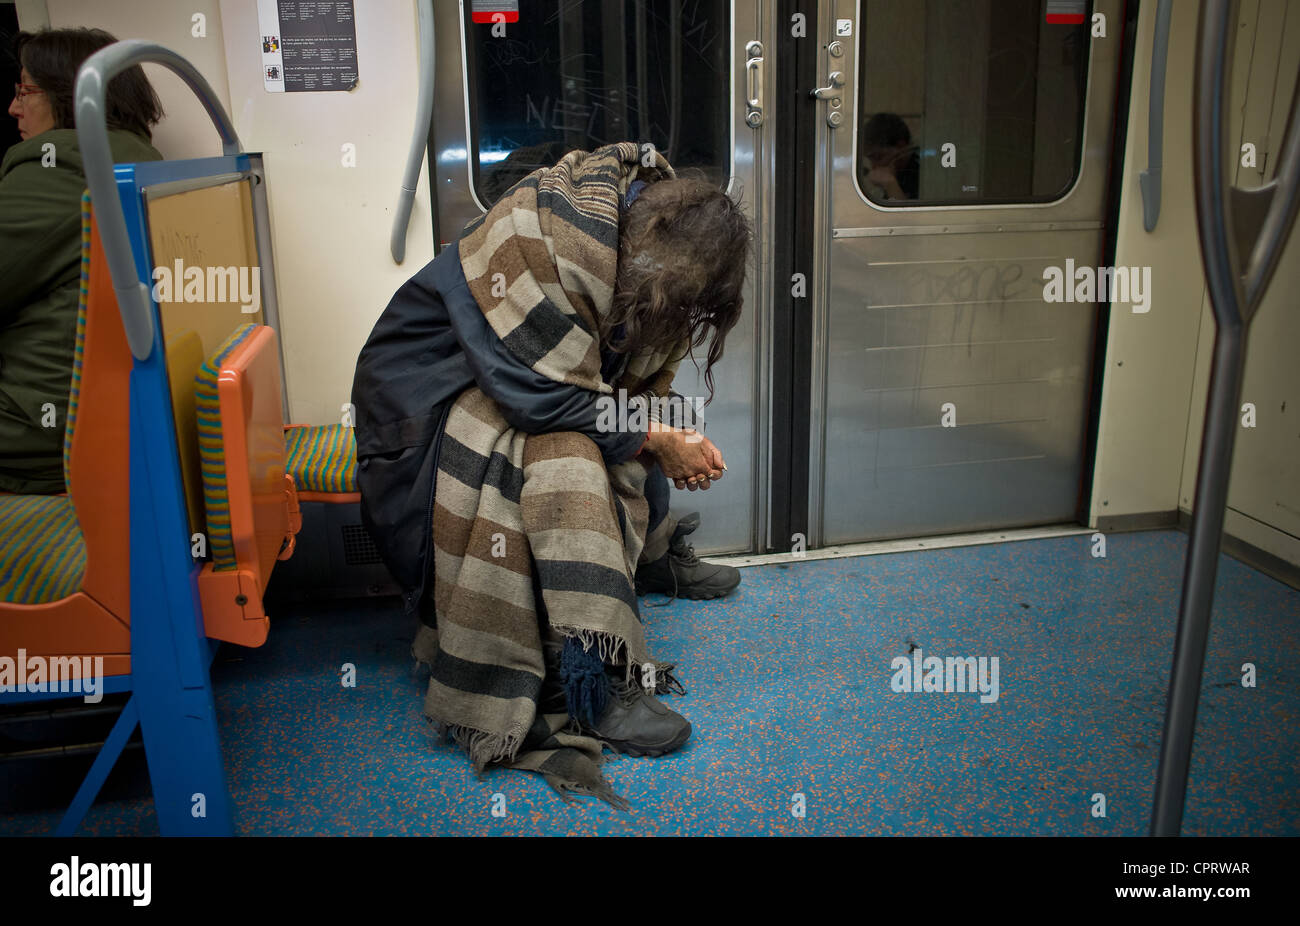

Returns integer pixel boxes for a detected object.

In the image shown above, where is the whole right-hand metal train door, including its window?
[809,0,1123,545]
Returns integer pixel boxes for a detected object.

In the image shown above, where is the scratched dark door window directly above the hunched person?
[464,0,731,205]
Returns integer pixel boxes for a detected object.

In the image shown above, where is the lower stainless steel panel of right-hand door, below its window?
[824,232,1097,544]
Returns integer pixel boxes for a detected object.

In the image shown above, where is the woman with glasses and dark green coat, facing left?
[0,29,163,494]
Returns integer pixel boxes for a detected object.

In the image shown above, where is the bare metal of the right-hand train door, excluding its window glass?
[810,0,1121,545]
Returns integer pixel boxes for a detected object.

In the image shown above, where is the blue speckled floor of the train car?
[0,532,1300,835]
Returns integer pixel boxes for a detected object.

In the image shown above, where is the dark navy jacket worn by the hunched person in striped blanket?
[352,245,645,613]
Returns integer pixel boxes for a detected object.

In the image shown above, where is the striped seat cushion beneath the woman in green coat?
[0,496,86,605]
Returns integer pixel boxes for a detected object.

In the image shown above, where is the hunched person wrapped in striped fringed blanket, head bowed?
[352,142,751,805]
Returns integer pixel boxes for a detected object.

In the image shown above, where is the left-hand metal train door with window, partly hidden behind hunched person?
[429,0,770,553]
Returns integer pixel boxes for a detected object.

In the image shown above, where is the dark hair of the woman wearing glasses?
[13,29,163,139]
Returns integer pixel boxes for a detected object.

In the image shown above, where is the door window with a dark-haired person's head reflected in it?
[857,0,1091,207]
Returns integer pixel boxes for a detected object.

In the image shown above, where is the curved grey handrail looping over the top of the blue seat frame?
[74,39,242,360]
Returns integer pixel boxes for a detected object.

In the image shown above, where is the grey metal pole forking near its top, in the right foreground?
[1151,0,1300,836]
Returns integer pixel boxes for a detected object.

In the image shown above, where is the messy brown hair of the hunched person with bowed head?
[601,176,753,402]
